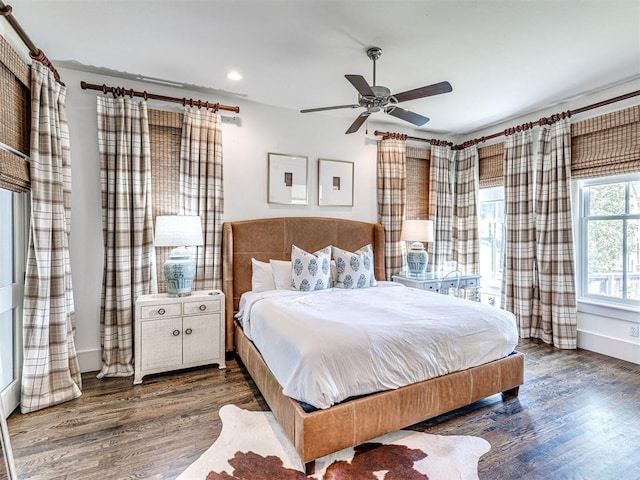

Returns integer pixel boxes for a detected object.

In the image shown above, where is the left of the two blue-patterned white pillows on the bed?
[291,245,331,292]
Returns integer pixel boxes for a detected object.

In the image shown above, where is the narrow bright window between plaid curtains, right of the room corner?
[478,187,504,294]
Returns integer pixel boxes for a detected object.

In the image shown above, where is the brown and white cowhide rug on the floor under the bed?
[178,405,491,480]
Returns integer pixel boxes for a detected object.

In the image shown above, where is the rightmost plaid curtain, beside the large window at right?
[530,119,577,348]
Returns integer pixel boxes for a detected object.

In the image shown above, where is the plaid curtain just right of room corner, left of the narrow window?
[453,145,480,278]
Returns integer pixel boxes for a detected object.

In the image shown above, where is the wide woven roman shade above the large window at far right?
[571,105,640,178]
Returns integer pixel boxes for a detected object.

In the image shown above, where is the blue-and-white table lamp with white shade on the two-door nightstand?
[154,215,204,297]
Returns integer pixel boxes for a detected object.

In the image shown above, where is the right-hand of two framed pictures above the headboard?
[318,159,354,207]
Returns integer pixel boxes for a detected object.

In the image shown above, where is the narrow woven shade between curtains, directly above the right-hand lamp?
[404,147,431,220]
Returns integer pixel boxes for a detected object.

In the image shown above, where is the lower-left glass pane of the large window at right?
[587,220,623,298]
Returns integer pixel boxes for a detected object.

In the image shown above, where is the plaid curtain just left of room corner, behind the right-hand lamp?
[429,145,455,271]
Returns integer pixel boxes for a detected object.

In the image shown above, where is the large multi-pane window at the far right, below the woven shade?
[577,174,640,305]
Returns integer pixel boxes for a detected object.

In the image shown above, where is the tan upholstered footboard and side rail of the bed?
[235,325,524,468]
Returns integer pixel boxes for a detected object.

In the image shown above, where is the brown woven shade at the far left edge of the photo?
[0,36,31,192]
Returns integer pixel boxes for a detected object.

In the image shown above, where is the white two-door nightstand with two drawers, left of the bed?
[133,290,226,385]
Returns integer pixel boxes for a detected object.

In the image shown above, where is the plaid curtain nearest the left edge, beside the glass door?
[20,62,82,413]
